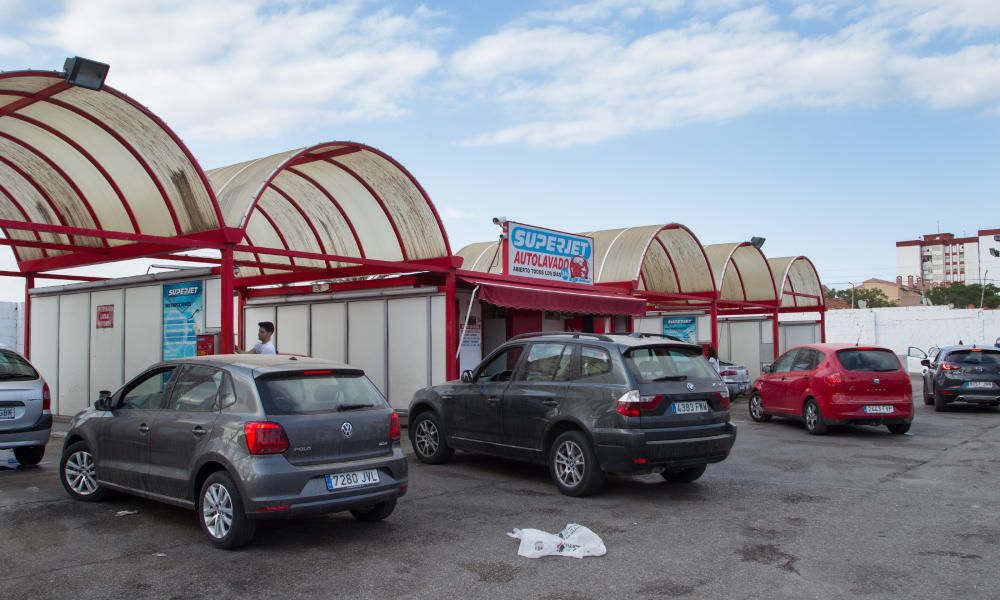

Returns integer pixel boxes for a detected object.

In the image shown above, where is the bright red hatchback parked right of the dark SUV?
[749,344,913,435]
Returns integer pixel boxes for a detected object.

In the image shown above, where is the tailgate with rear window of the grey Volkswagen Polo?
[257,369,392,465]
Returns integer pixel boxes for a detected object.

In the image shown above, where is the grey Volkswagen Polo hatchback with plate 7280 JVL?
[60,355,407,548]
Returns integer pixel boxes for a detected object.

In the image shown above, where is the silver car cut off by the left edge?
[0,347,52,466]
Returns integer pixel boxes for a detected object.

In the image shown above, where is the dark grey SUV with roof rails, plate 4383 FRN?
[409,333,736,496]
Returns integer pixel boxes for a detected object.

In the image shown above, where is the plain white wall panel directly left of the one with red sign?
[58,292,91,415]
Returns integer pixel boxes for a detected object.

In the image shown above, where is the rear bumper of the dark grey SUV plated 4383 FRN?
[593,422,736,473]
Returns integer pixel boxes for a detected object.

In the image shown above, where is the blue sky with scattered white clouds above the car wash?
[0,0,1000,300]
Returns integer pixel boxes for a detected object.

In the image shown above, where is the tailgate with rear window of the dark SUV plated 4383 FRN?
[623,344,729,429]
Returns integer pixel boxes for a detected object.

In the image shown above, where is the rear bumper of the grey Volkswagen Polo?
[240,446,408,519]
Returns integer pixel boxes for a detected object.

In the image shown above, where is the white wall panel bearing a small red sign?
[87,289,125,401]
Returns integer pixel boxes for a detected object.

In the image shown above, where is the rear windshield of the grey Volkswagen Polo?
[257,371,388,415]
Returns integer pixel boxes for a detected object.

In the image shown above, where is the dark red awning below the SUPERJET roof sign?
[462,277,646,317]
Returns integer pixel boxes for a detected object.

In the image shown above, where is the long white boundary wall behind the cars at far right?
[782,306,1000,355]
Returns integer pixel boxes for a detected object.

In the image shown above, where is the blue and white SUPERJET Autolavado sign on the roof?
[507,223,594,283]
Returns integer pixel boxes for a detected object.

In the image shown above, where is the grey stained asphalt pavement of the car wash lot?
[0,383,1000,600]
